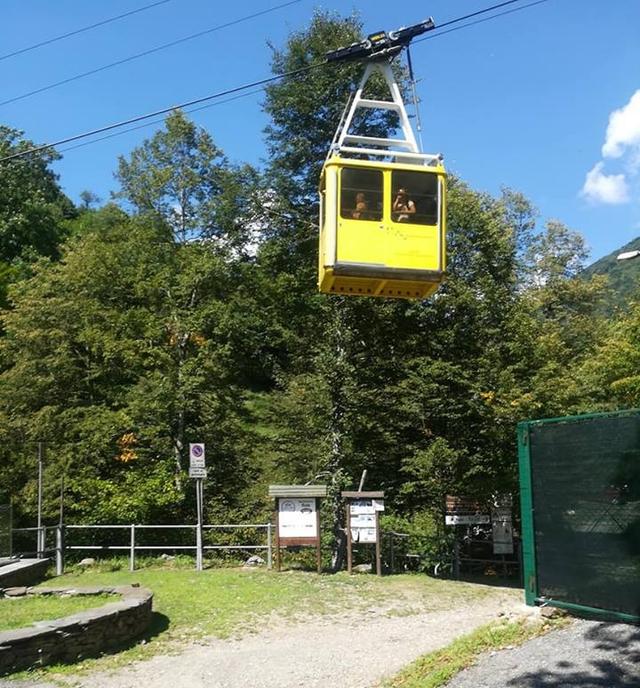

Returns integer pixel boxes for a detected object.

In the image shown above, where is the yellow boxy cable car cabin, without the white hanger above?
[319,156,446,298]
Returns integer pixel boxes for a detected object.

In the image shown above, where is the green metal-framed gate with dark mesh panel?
[518,410,640,622]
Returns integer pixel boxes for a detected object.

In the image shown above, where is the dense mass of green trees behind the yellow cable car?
[0,14,640,552]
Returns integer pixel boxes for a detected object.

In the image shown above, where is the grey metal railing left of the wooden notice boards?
[13,523,273,575]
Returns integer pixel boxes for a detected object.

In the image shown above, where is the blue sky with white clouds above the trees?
[0,0,640,259]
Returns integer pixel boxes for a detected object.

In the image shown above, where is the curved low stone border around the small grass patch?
[0,585,153,675]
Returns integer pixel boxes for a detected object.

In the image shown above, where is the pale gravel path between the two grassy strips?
[0,589,524,688]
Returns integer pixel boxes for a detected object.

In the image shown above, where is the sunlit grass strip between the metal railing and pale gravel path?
[12,562,519,680]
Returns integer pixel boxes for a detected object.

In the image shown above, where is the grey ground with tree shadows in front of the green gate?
[447,621,640,688]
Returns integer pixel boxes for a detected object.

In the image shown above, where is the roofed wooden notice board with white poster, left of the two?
[269,485,327,573]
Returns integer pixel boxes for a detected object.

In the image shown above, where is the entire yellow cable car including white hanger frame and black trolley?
[318,19,446,298]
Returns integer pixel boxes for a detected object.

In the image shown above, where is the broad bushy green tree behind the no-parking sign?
[0,207,251,522]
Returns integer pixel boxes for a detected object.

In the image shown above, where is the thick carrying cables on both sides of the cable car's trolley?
[0,0,548,163]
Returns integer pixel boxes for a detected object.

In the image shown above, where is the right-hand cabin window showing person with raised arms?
[391,171,438,225]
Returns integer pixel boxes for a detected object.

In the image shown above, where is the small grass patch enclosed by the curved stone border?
[0,595,120,631]
